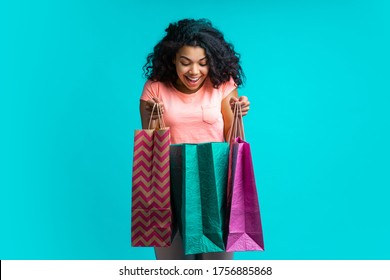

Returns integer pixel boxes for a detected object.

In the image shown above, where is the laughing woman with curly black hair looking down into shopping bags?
[140,19,249,259]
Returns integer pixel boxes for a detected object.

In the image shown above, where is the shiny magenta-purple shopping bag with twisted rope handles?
[226,102,264,252]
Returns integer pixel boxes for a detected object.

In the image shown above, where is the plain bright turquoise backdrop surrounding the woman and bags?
[0,0,390,259]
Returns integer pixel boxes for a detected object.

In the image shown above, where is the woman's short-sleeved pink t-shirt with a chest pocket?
[141,79,237,144]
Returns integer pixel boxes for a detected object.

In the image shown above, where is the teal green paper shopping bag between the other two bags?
[170,142,229,255]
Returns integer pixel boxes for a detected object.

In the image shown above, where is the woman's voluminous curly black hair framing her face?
[143,19,245,88]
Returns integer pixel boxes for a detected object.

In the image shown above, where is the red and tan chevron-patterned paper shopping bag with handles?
[131,104,172,247]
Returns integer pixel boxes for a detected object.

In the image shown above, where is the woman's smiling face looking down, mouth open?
[173,46,209,93]
